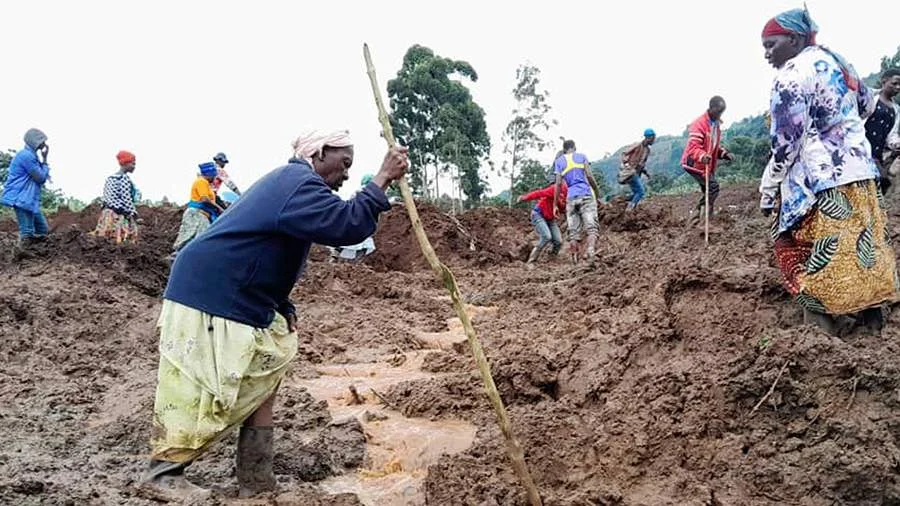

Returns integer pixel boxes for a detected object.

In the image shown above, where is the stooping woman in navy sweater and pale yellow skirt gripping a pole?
[142,131,409,501]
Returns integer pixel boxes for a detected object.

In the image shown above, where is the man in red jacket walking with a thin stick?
[681,96,734,222]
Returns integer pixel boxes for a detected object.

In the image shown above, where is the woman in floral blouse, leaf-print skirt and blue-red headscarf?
[759,9,900,334]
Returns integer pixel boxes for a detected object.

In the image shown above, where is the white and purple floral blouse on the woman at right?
[759,46,878,233]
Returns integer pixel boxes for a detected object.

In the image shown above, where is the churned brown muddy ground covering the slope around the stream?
[0,187,900,506]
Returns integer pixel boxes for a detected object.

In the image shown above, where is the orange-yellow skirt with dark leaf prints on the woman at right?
[774,179,900,315]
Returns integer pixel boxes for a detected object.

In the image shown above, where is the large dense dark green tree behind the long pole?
[388,45,491,206]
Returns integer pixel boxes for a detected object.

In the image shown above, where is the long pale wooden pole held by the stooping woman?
[363,44,542,506]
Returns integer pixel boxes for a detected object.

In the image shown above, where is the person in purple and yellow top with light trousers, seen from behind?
[553,140,600,265]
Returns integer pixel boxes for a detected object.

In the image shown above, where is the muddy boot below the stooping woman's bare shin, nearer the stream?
[236,427,275,497]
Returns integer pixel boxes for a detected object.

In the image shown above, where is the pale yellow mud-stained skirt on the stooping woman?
[150,300,297,463]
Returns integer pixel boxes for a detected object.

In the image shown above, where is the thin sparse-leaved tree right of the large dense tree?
[501,64,556,207]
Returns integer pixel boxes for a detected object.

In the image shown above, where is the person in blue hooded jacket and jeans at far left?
[0,128,50,250]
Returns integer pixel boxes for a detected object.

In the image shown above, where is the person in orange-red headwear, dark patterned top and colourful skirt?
[91,151,138,244]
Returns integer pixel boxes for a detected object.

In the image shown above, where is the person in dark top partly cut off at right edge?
[866,69,900,192]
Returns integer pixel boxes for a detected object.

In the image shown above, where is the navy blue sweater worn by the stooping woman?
[163,161,391,328]
